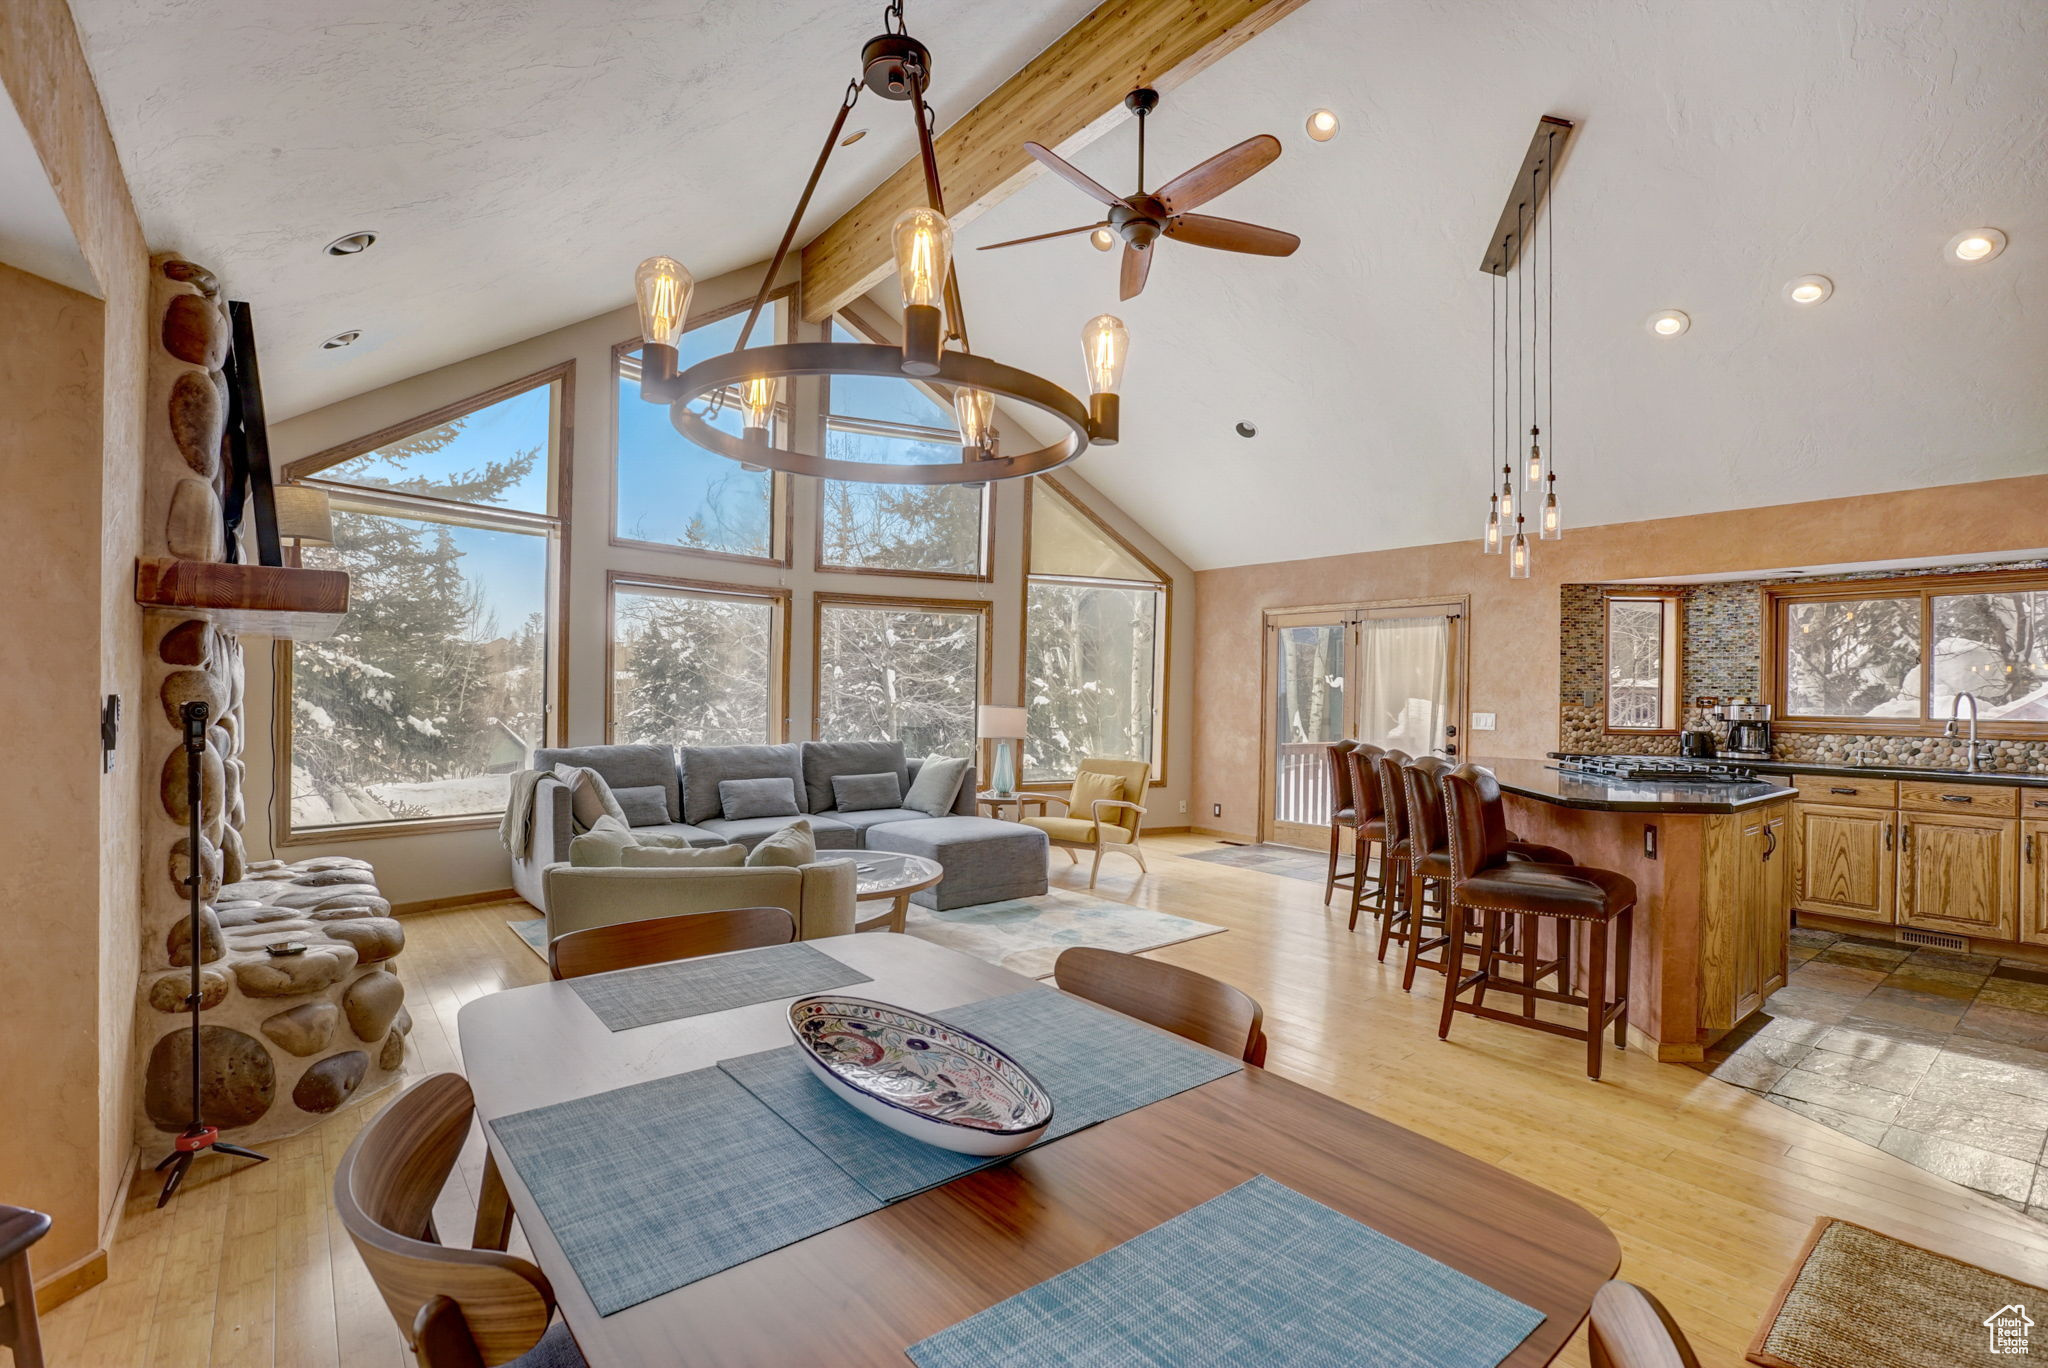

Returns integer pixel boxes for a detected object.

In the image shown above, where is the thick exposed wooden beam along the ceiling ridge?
[803,0,1307,324]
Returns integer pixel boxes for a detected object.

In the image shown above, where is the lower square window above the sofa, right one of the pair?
[817,594,987,758]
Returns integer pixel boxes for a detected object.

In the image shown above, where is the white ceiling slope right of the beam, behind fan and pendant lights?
[961,0,2048,573]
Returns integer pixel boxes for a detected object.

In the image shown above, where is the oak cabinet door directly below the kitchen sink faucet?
[1898,811,2021,940]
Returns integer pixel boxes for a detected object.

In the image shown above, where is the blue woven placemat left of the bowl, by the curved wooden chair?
[492,1069,883,1315]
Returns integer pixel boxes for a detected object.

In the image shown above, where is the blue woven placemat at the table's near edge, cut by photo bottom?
[909,1178,1544,1368]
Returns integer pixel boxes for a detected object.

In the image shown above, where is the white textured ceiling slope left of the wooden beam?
[72,0,1090,418]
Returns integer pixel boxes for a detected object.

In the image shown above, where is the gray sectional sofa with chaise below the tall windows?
[512,741,1047,911]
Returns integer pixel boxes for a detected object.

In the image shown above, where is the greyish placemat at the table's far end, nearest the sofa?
[569,940,870,1030]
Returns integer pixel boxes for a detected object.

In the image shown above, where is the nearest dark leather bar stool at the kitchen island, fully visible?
[1436,764,1636,1079]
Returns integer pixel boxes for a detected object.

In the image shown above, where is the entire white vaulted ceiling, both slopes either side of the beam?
[74,0,2048,567]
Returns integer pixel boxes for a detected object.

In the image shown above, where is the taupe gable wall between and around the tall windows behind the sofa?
[244,266,1194,903]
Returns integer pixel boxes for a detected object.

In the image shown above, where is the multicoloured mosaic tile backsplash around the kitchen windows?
[1559,561,2048,774]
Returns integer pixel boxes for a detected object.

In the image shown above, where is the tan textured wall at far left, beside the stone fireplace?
[0,0,150,1282]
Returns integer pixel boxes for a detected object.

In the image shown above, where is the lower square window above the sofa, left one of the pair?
[610,575,788,745]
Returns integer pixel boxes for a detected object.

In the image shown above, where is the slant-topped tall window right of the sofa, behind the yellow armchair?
[1024,479,1167,782]
